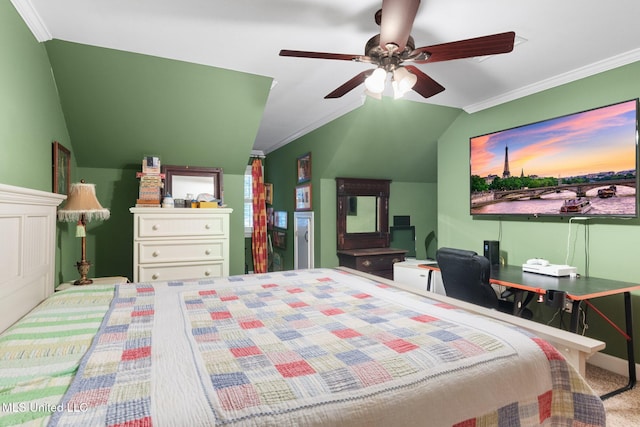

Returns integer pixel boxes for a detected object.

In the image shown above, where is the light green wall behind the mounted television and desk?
[438,63,640,358]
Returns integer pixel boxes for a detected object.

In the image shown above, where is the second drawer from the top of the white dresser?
[137,240,227,264]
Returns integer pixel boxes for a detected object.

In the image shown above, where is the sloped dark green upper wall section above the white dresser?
[46,40,271,174]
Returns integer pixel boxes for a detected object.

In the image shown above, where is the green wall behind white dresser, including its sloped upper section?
[41,40,271,282]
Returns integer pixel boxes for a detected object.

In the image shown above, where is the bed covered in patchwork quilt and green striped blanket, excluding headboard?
[0,183,605,426]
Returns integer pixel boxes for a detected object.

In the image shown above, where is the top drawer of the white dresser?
[136,214,229,239]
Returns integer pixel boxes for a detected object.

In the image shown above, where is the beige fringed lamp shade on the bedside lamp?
[58,182,111,222]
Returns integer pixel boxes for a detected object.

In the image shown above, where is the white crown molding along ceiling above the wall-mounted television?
[463,49,640,114]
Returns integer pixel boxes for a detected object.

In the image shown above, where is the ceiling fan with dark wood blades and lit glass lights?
[280,0,515,99]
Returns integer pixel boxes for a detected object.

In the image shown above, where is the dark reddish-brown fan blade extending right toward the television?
[415,31,516,64]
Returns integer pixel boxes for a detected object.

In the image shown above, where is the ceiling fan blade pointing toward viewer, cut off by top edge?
[380,0,420,52]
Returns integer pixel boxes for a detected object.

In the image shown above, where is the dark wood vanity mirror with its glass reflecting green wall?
[336,178,391,250]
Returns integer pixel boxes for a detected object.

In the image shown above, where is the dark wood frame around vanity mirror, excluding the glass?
[336,178,391,250]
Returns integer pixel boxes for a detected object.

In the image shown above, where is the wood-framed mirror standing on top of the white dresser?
[162,165,223,200]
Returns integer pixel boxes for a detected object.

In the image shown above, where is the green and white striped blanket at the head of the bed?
[0,285,113,426]
